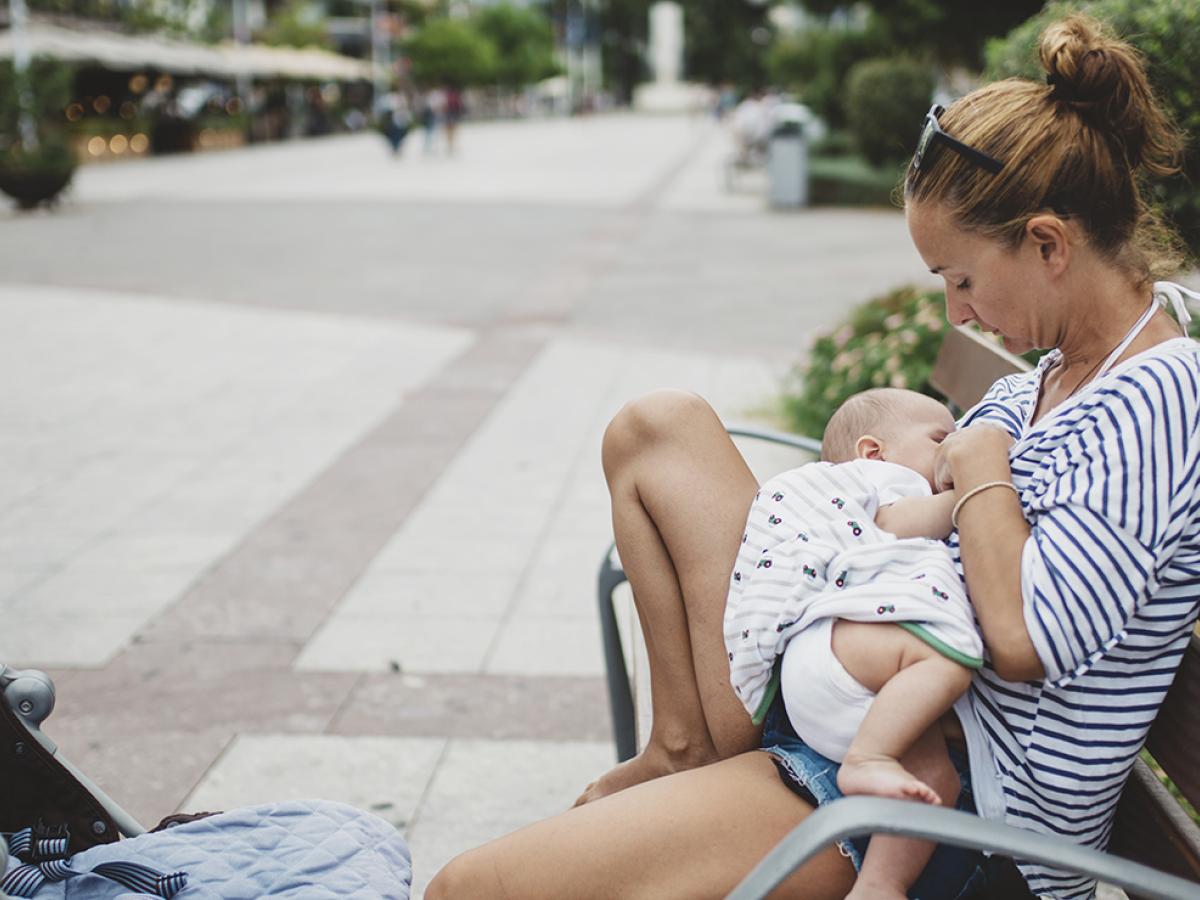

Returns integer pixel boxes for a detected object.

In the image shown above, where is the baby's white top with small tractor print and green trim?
[725,460,983,722]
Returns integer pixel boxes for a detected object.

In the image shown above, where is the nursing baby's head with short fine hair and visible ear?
[821,388,954,490]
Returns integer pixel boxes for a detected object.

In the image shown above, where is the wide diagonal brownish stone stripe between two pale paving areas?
[138,330,544,652]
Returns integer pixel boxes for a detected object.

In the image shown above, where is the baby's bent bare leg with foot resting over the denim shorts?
[833,619,971,803]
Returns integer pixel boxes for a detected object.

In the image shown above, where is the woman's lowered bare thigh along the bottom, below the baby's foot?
[425,752,854,900]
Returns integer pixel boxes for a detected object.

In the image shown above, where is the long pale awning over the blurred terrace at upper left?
[0,23,372,82]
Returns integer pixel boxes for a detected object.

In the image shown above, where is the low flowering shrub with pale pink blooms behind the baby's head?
[784,288,948,437]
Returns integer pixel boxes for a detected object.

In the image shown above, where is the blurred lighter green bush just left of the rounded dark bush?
[767,25,892,128]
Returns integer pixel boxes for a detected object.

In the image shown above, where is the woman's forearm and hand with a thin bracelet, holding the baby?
[935,425,1045,682]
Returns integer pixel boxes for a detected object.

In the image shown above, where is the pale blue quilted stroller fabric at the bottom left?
[8,800,413,900]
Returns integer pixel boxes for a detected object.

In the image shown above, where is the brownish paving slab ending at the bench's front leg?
[330,674,612,742]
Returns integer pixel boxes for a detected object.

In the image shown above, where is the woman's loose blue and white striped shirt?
[950,338,1200,898]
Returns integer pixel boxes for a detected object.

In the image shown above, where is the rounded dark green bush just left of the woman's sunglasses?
[845,58,934,166]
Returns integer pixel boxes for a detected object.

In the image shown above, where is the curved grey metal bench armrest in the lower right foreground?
[728,797,1200,900]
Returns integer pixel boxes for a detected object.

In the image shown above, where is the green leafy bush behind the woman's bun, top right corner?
[985,0,1200,256]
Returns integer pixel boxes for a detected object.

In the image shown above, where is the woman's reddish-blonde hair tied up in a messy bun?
[904,14,1183,286]
